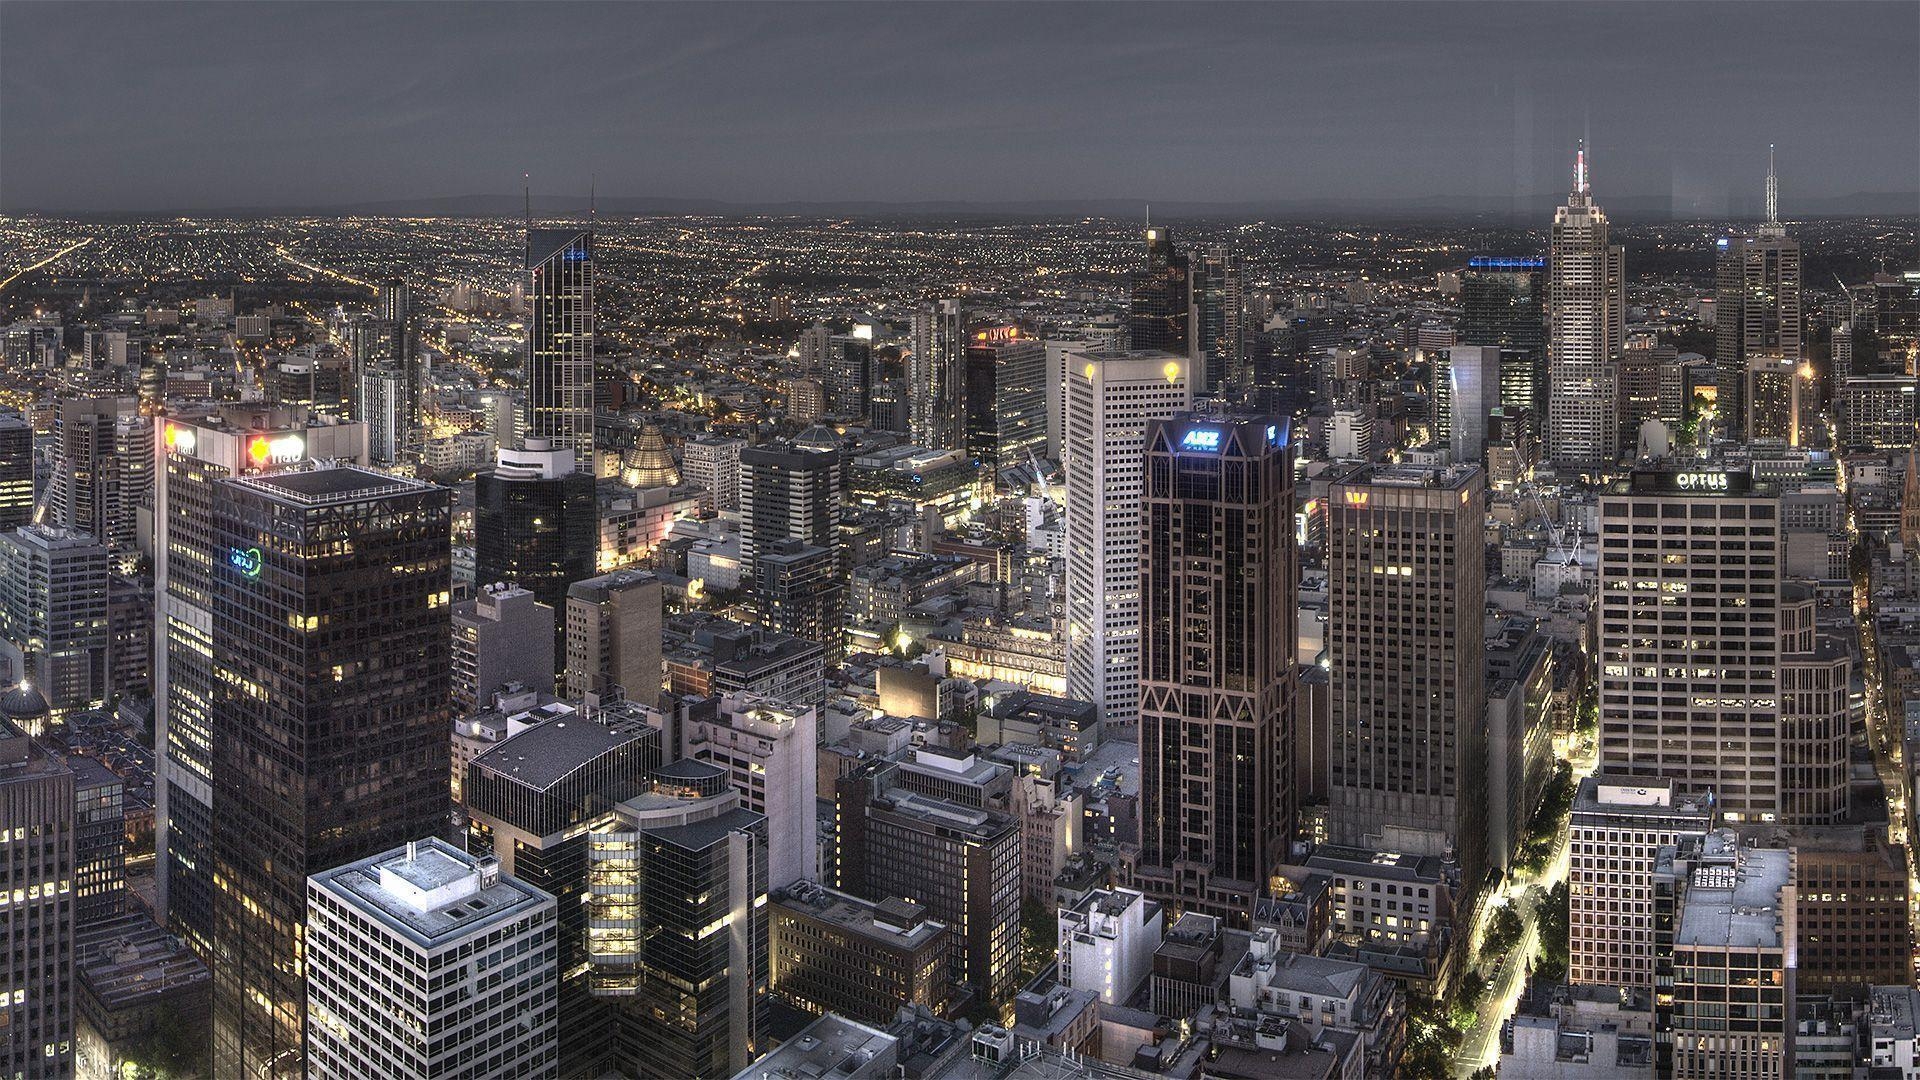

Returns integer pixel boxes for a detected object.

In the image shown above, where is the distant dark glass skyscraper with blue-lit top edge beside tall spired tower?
[1459,256,1548,432]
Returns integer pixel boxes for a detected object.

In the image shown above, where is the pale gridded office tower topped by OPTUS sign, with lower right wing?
[1599,465,1849,824]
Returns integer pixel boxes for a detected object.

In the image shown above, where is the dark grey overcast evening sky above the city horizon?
[0,0,1920,215]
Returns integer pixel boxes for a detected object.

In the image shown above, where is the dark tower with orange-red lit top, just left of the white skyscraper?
[962,327,1046,484]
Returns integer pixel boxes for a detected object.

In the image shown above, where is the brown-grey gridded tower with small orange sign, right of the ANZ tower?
[1327,457,1486,896]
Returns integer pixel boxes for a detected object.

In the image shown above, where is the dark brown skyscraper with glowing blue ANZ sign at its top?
[1131,409,1298,914]
